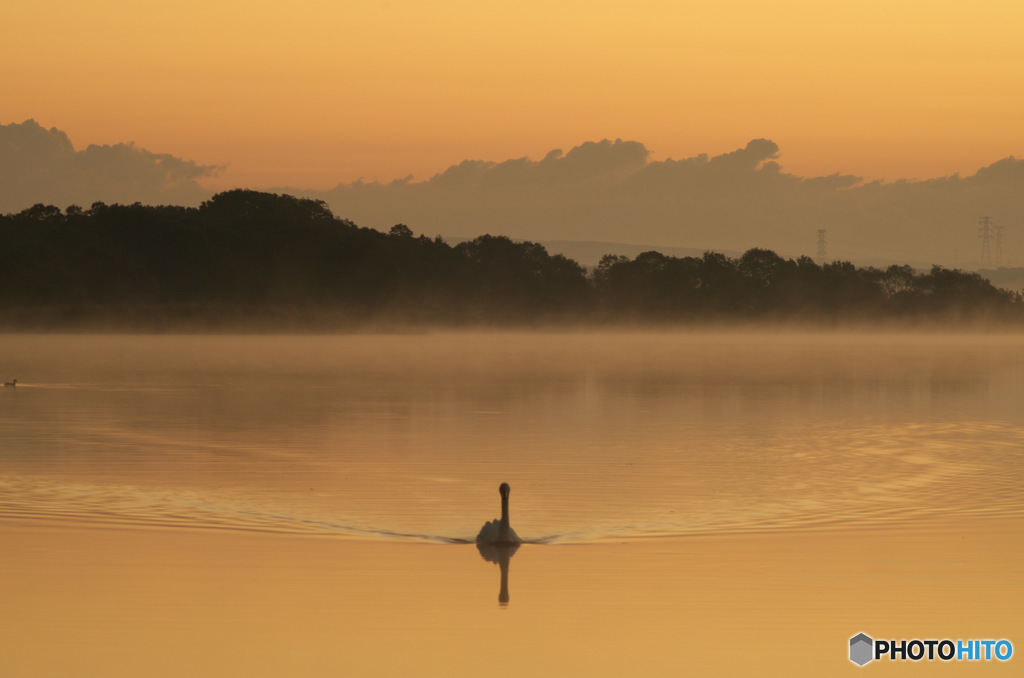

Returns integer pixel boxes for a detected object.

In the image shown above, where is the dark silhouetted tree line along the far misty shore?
[0,189,1024,329]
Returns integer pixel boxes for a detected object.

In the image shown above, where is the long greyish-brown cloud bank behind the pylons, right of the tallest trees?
[306,139,1024,267]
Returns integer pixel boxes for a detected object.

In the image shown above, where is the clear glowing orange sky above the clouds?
[0,0,1024,188]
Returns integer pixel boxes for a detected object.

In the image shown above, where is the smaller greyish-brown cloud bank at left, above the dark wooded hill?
[0,120,219,213]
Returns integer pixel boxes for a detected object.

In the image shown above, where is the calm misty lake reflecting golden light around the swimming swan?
[0,330,1024,676]
